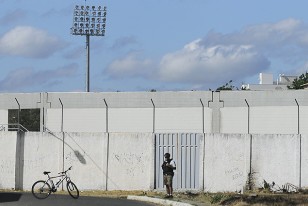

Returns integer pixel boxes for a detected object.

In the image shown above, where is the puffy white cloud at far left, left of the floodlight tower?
[0,26,65,58]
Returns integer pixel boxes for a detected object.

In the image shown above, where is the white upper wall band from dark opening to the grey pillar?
[46,107,212,133]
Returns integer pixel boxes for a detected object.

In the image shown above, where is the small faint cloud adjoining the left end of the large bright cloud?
[106,52,153,78]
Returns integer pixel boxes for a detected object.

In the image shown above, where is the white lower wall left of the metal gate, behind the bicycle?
[0,132,154,190]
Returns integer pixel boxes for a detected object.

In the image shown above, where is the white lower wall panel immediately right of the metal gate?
[204,134,250,192]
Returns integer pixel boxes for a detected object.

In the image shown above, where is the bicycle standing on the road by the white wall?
[32,167,79,199]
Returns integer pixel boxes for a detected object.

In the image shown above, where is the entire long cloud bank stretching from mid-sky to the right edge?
[108,18,308,87]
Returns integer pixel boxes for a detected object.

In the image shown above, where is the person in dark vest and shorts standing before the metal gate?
[161,153,176,198]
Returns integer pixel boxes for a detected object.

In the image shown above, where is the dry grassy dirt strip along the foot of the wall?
[0,190,308,206]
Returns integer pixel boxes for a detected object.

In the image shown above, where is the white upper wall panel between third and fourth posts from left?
[108,108,153,133]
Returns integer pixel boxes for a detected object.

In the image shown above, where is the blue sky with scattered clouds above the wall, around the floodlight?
[0,0,308,92]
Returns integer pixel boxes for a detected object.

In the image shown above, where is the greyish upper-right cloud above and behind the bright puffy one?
[202,18,308,63]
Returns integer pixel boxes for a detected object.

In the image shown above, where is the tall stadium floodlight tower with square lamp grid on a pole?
[71,5,107,92]
